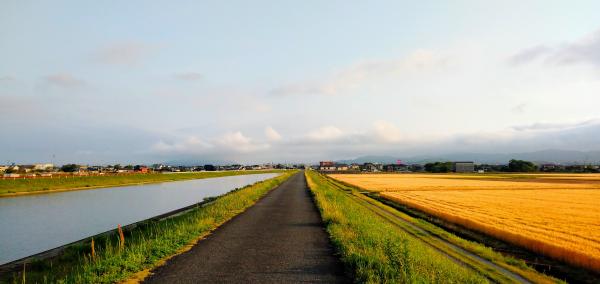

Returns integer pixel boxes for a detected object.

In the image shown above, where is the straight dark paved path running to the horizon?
[145,172,349,283]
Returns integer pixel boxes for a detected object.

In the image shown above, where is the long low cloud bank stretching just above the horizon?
[146,117,600,163]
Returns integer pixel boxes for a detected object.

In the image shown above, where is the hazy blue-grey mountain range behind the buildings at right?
[337,149,600,164]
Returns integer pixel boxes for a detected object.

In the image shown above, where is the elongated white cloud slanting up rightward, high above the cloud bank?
[271,50,449,96]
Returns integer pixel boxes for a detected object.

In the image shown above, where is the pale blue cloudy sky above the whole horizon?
[0,0,600,164]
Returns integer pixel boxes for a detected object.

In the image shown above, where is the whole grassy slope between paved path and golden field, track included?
[307,171,557,283]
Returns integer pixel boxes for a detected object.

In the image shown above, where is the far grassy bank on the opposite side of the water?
[0,170,278,197]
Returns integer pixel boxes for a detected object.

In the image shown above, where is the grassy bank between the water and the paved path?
[0,171,295,283]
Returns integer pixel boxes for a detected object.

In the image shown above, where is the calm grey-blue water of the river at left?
[0,173,278,264]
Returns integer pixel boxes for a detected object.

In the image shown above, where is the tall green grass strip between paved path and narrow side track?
[306,171,488,283]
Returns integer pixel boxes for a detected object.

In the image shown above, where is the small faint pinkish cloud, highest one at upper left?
[94,42,157,66]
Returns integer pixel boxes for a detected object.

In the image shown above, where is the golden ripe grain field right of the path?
[331,174,600,271]
